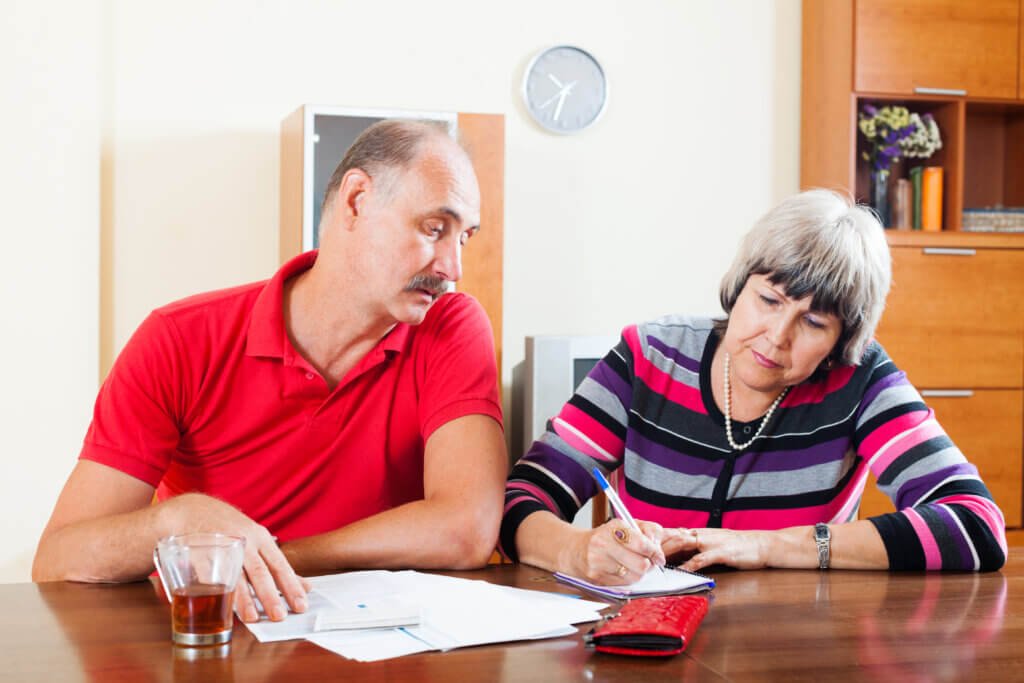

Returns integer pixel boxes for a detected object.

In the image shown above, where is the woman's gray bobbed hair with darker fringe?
[719,189,892,366]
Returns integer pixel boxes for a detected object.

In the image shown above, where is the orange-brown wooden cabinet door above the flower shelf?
[854,0,1021,99]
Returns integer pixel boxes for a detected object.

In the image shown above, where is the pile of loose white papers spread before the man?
[246,570,607,661]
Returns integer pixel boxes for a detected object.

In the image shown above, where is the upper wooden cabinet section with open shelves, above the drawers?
[800,0,1024,230]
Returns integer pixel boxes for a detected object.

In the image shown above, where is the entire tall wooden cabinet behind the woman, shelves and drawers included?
[800,0,1024,527]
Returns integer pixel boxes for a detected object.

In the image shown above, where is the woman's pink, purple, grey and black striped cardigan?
[501,316,1007,570]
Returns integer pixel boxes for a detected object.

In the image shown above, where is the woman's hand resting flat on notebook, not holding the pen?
[662,528,772,571]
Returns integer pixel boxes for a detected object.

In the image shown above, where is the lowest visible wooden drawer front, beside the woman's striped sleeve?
[860,389,1024,526]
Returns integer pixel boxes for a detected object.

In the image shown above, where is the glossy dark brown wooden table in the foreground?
[8,555,1024,683]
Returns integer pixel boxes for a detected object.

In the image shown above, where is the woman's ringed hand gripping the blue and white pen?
[560,519,666,586]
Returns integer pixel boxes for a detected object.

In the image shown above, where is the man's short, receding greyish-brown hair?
[321,119,447,216]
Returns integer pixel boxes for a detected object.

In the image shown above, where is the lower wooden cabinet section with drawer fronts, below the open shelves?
[861,232,1024,526]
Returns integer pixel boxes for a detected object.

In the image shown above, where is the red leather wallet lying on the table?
[584,595,708,656]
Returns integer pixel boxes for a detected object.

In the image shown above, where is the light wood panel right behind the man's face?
[457,114,505,370]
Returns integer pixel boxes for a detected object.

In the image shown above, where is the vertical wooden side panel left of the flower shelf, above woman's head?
[800,0,857,193]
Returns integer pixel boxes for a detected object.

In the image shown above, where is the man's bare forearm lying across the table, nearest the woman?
[282,501,501,574]
